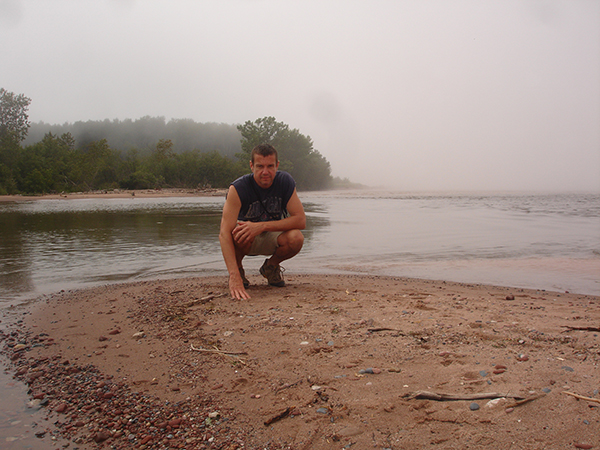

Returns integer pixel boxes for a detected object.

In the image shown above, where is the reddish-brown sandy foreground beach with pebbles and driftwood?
[1,274,600,449]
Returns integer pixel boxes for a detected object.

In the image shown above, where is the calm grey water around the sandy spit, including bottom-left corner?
[0,191,600,449]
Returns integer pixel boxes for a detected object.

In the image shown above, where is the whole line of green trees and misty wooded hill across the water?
[0,88,338,195]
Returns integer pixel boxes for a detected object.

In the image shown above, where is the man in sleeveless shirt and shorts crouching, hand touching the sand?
[219,144,306,300]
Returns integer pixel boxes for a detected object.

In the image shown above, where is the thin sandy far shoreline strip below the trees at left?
[0,189,227,203]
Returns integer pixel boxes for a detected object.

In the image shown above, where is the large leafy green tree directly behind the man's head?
[236,117,332,190]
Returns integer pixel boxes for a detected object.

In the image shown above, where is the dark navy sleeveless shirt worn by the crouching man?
[231,170,296,222]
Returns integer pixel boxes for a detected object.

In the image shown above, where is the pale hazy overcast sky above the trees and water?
[0,0,600,191]
